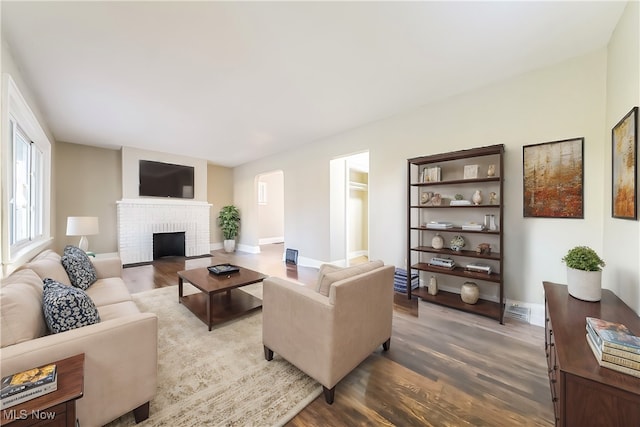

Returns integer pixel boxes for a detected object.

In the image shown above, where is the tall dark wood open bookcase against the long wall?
[407,144,505,323]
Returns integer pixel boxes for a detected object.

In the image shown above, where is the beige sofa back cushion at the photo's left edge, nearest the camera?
[0,270,47,348]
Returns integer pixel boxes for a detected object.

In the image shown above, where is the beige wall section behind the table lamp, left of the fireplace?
[53,142,122,253]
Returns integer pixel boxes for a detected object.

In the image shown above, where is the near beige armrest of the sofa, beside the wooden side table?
[0,313,158,426]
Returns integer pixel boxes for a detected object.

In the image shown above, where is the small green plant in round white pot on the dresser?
[562,246,605,301]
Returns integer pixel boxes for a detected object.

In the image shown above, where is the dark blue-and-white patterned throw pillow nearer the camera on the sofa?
[42,279,100,334]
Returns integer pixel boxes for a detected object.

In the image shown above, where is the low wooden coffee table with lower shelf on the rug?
[178,267,267,330]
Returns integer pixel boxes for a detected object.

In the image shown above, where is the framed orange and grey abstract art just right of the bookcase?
[522,138,584,218]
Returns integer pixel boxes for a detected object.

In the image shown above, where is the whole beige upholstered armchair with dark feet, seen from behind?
[262,261,395,404]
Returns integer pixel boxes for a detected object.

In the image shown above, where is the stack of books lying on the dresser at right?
[586,317,640,378]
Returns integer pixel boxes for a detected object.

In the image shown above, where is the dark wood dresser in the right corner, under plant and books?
[543,282,640,427]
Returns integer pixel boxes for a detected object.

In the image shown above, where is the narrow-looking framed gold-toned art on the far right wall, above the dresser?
[611,107,638,220]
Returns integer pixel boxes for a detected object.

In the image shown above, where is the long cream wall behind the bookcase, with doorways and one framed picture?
[234,49,607,310]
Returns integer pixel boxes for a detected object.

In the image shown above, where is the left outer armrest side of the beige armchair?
[262,277,334,382]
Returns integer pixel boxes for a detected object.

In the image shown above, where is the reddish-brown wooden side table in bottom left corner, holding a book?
[0,353,84,427]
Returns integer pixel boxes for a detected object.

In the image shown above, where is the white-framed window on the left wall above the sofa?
[0,74,51,272]
